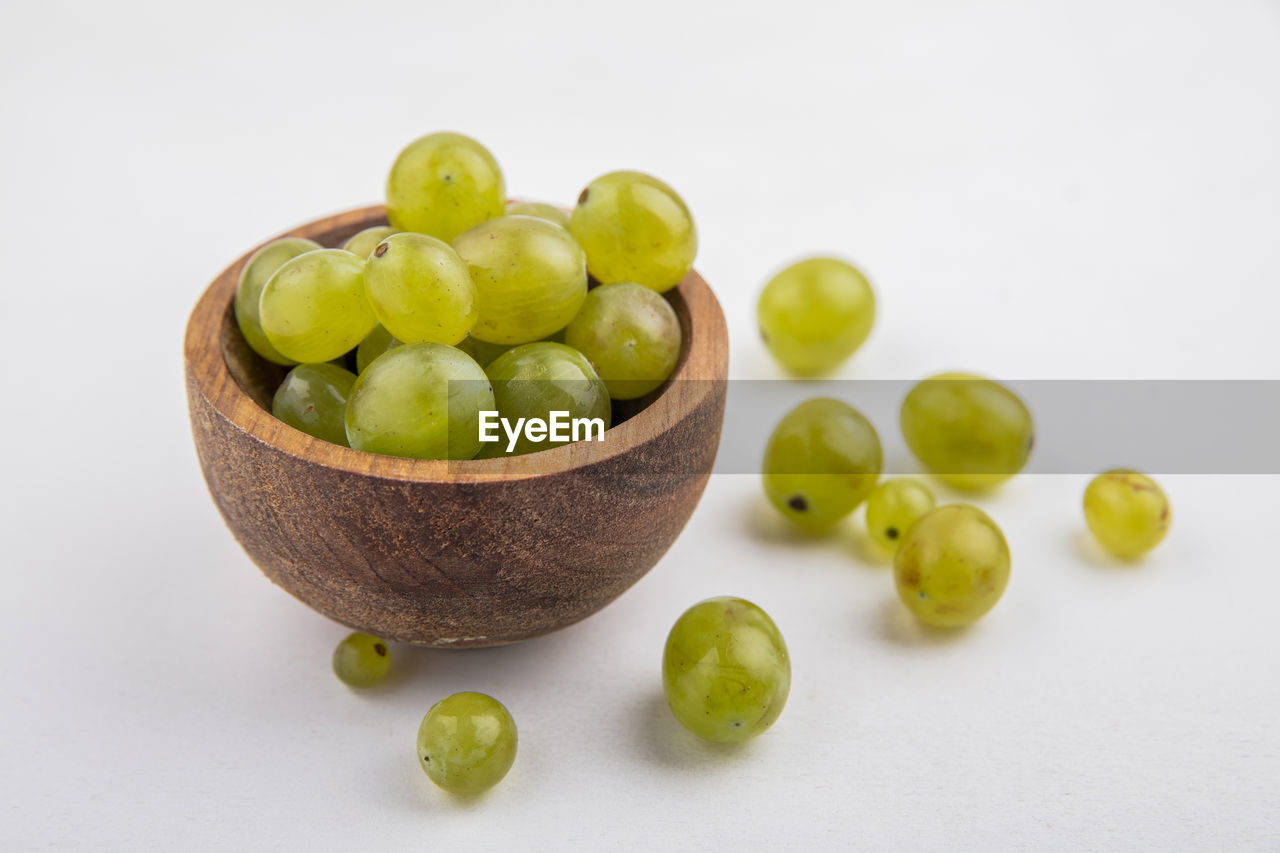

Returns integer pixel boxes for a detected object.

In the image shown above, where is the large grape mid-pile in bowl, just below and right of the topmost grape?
[453,216,586,345]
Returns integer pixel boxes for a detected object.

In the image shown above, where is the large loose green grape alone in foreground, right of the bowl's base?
[662,597,791,743]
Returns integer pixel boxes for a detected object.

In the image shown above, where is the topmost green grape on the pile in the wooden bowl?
[387,133,507,242]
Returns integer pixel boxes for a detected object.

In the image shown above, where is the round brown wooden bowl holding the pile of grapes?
[186,206,728,648]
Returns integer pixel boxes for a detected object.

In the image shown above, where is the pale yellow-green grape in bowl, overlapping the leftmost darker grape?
[259,248,378,364]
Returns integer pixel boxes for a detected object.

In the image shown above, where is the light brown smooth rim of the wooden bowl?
[183,205,728,483]
